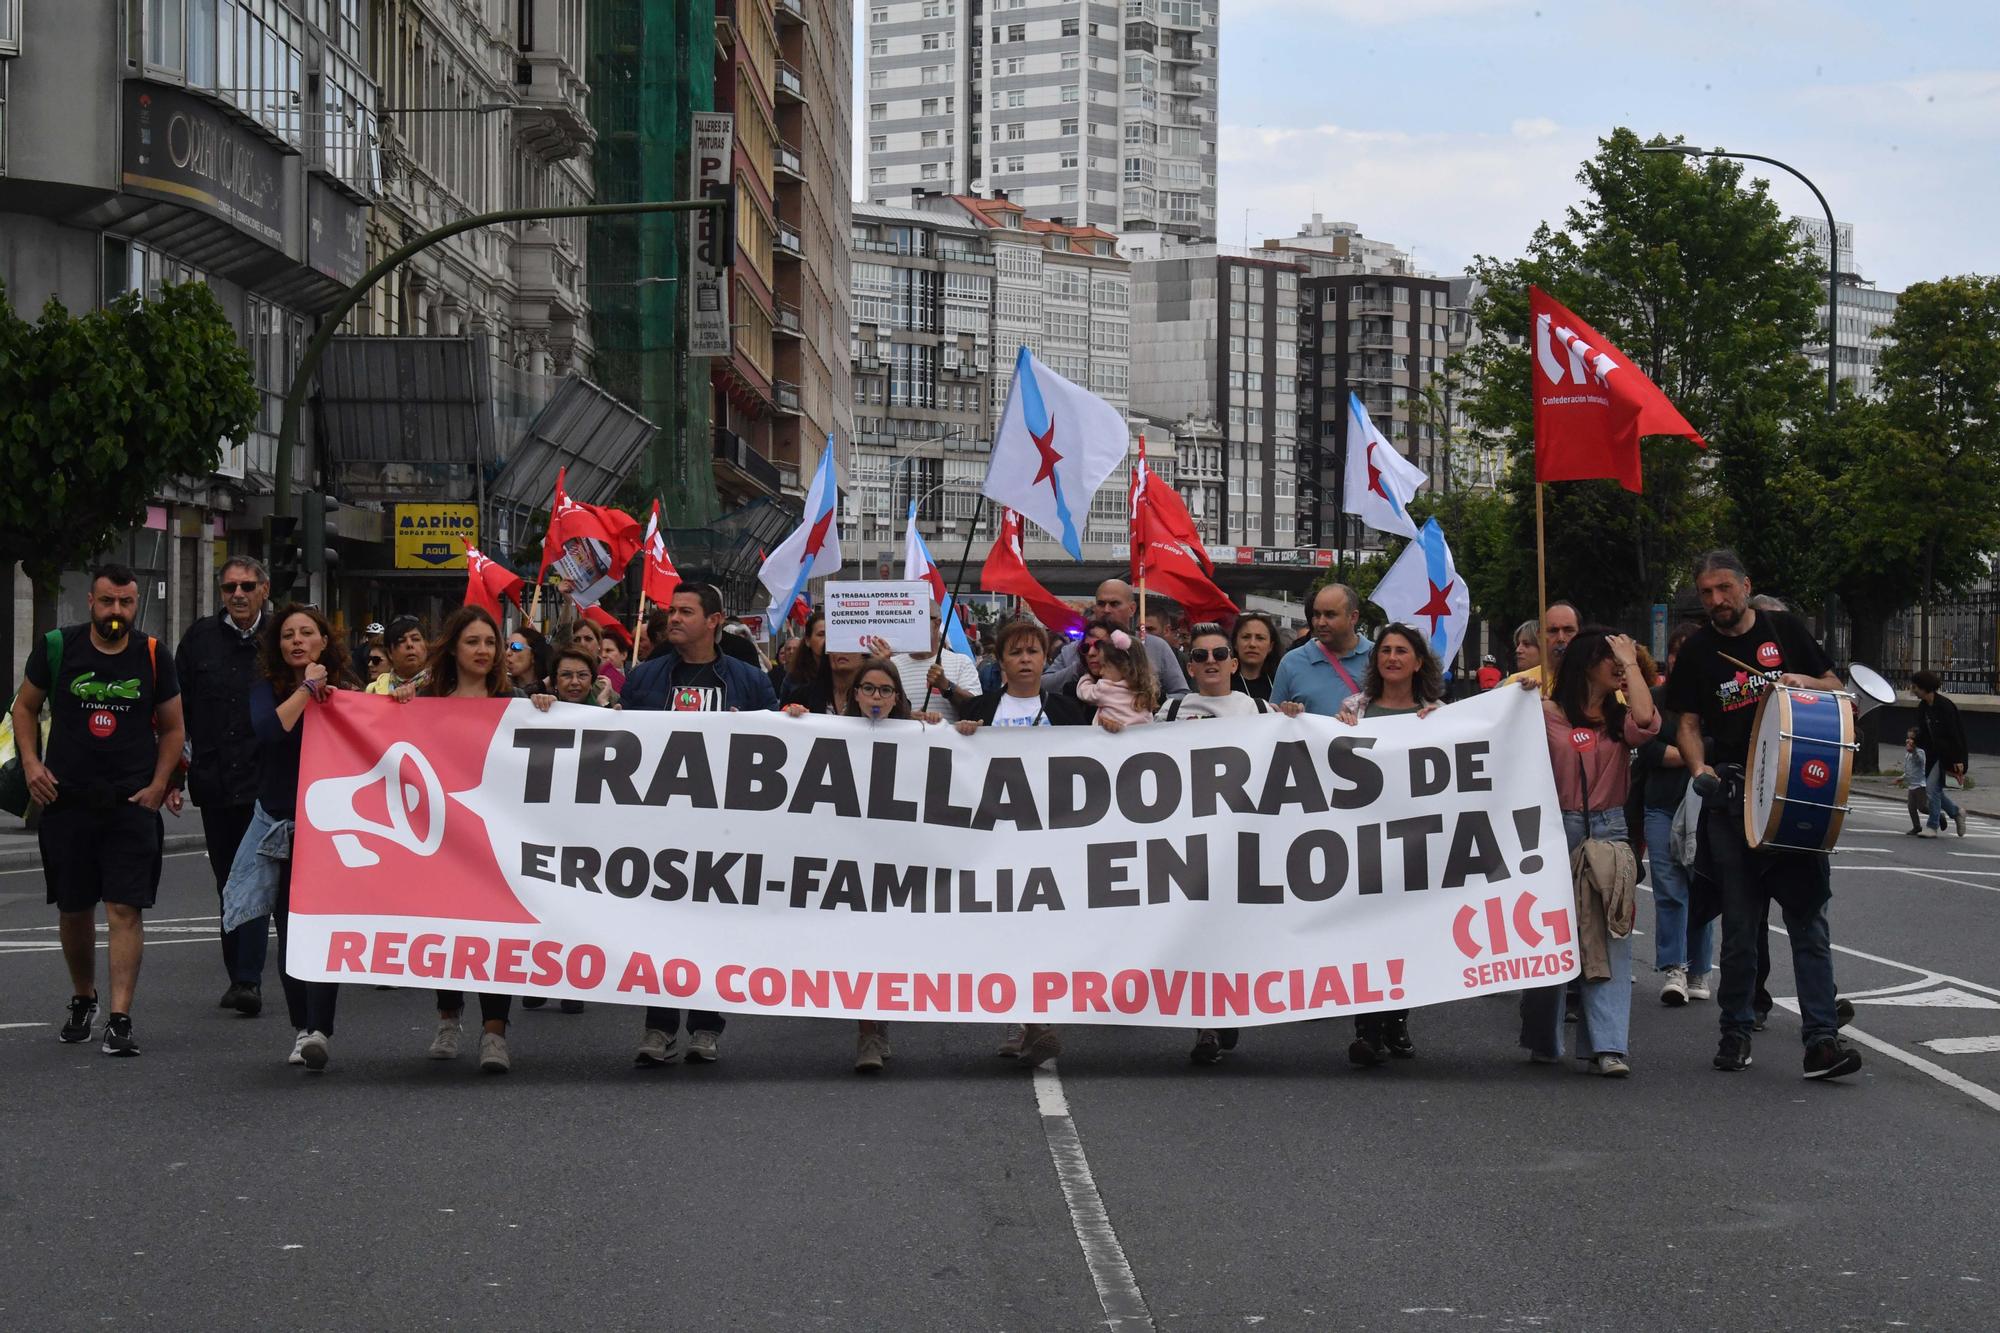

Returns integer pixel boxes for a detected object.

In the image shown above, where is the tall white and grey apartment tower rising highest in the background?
[864,0,1220,238]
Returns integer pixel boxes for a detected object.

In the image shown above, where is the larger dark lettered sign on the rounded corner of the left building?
[122,80,290,248]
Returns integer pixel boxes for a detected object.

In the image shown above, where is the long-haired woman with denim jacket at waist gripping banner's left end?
[248,602,358,1069]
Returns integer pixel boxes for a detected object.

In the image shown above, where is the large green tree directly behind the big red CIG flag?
[1466,128,1818,618]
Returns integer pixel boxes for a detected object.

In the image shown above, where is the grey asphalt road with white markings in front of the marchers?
[0,788,2000,1331]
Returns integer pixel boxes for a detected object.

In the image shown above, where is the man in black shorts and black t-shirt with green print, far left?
[14,564,184,1055]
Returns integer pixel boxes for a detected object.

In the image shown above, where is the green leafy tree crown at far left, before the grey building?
[0,282,258,586]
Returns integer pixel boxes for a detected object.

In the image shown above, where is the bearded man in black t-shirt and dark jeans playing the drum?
[1666,550,1862,1079]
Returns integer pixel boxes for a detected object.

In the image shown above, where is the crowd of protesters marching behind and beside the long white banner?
[12,552,1872,1077]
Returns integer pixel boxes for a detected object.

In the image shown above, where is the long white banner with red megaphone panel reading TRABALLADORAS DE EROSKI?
[288,691,1578,1027]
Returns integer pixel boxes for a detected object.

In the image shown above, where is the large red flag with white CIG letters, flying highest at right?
[1528,286,1708,492]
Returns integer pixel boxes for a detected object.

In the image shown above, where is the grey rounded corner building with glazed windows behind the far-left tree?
[0,0,382,660]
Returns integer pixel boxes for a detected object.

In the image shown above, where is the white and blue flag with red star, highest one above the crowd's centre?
[984,346,1132,560]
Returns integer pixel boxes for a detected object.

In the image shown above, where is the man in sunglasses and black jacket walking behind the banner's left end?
[174,556,270,1019]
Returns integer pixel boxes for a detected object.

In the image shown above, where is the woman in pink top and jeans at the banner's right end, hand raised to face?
[1520,626,1660,1079]
